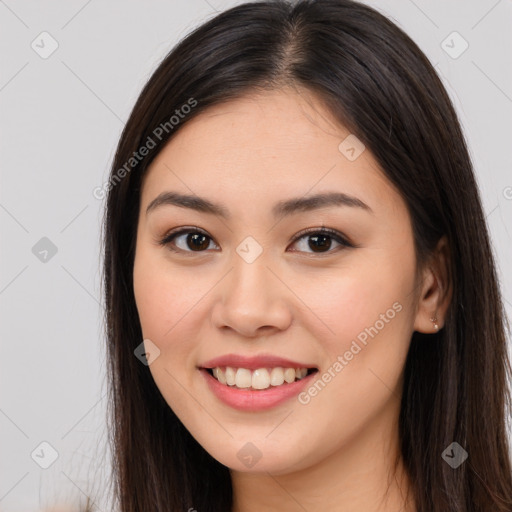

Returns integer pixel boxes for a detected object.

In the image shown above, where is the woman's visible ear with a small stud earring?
[414,236,453,334]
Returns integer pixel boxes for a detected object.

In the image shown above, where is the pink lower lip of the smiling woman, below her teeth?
[199,368,318,411]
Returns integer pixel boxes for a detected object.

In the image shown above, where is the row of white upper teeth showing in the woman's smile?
[212,366,308,389]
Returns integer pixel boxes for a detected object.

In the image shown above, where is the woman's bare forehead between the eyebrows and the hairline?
[141,89,404,218]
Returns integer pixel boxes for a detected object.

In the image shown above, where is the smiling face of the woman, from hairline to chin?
[133,90,417,474]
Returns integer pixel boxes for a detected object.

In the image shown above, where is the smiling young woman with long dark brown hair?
[104,0,512,512]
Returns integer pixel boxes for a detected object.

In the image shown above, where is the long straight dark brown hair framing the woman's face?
[103,0,512,512]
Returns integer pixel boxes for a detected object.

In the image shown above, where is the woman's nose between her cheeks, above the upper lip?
[212,255,292,338]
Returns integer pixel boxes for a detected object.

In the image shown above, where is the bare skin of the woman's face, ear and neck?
[133,89,450,512]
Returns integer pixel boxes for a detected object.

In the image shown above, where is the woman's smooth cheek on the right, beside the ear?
[301,242,416,392]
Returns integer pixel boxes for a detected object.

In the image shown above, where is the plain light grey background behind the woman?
[0,0,512,512]
